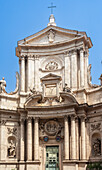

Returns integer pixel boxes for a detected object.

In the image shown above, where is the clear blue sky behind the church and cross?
[0,0,102,92]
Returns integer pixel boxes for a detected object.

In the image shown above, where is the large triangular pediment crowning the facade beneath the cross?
[18,26,92,46]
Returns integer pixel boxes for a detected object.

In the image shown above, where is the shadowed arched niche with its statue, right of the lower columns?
[92,133,101,157]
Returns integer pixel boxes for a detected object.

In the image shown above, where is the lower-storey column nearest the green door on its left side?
[34,118,39,161]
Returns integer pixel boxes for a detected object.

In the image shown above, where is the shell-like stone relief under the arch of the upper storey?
[45,61,58,71]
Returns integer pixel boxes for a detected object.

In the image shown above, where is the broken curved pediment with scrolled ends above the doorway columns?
[25,92,78,108]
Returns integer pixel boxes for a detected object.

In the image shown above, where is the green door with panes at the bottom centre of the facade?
[46,146,59,170]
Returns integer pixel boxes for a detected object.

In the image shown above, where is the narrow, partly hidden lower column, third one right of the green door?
[75,118,79,160]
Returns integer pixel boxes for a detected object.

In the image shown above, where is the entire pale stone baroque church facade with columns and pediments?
[0,14,102,170]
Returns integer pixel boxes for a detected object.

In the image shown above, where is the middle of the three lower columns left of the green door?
[27,117,32,161]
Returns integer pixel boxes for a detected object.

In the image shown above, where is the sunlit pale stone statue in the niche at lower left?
[8,139,16,158]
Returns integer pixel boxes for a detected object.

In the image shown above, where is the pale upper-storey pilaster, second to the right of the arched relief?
[71,50,78,89]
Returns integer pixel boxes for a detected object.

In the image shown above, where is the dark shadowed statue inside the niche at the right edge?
[93,138,101,156]
